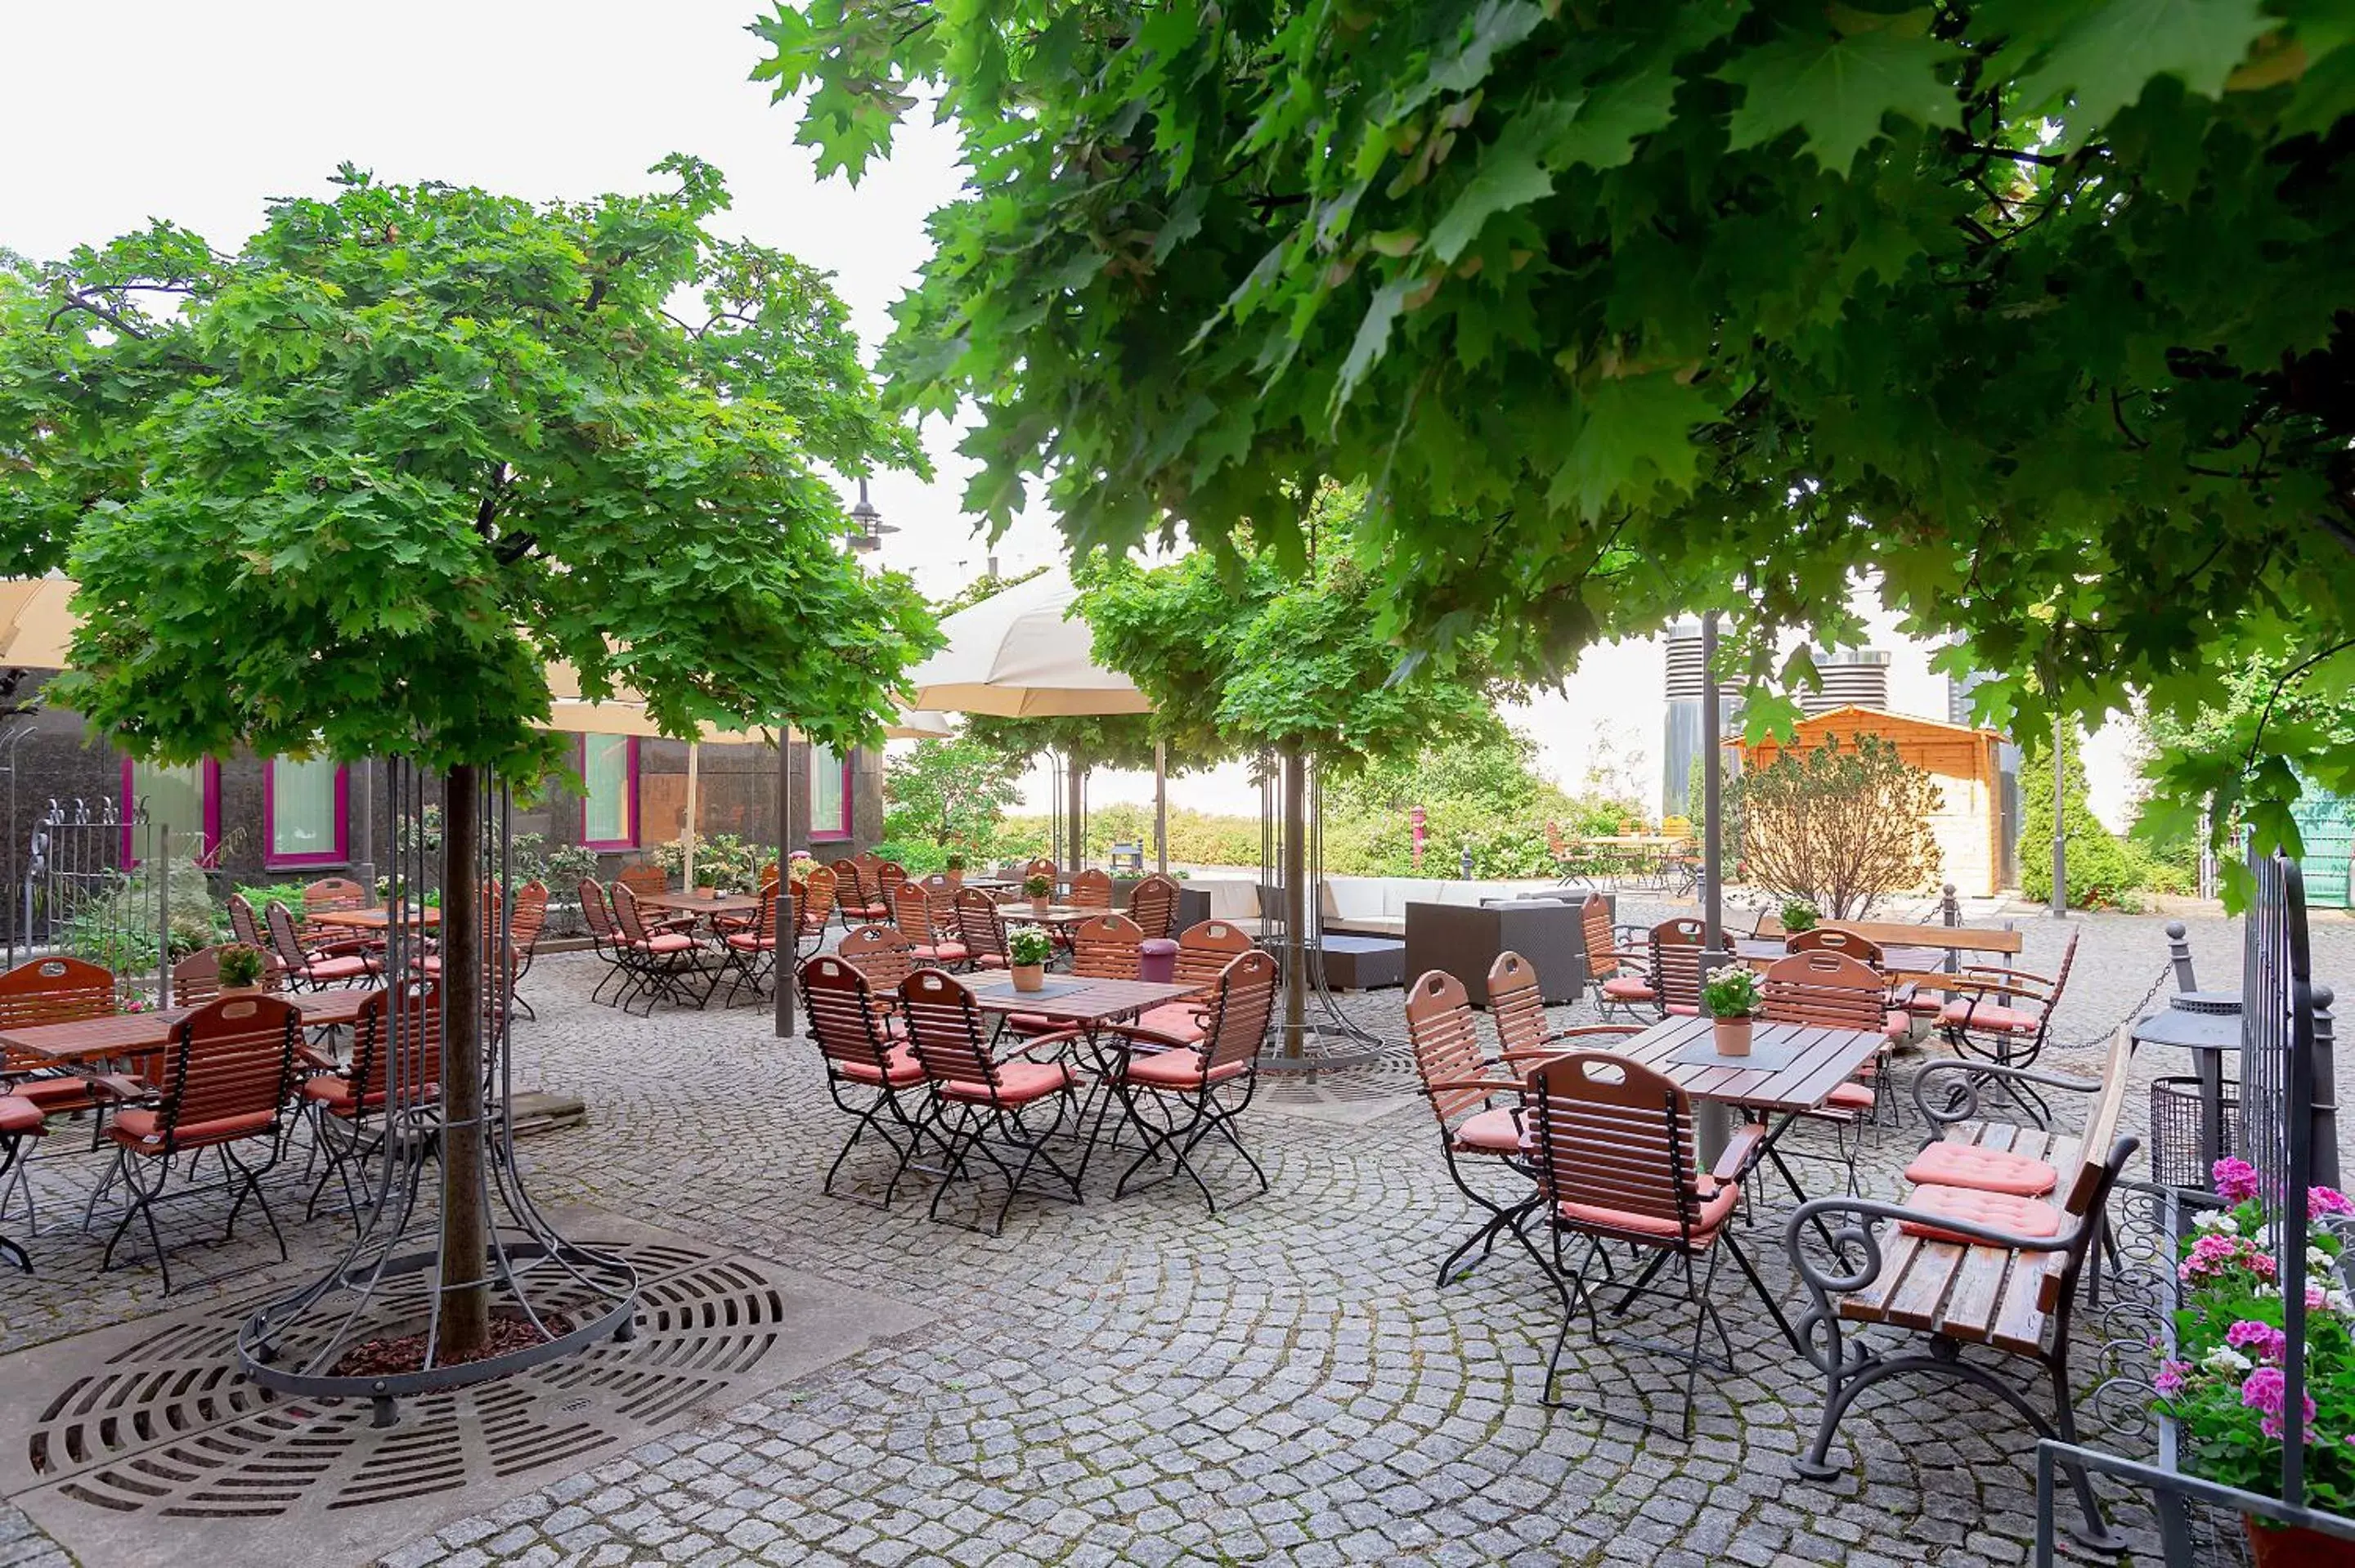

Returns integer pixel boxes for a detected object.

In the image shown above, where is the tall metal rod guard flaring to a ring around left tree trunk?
[238,758,638,1427]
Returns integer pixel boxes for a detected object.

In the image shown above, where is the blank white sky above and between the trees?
[0,0,2124,817]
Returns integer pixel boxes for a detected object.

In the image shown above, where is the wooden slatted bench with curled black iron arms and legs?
[1785,1029,2138,1552]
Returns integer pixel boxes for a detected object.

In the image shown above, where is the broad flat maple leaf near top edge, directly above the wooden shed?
[1717,30,1962,174]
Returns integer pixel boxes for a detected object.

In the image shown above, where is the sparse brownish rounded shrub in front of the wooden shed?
[1738,732,1943,921]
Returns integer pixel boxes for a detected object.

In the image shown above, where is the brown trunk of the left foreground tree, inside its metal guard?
[438,765,490,1363]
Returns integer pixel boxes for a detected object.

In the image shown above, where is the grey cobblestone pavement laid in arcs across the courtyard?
[0,904,2355,1568]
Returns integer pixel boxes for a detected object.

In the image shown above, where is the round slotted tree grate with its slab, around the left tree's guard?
[0,1222,923,1563]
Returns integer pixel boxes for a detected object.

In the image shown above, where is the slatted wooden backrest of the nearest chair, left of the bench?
[1528,1052,1696,1229]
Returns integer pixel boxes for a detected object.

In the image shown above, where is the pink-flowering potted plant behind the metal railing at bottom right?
[2150,1158,2355,1568]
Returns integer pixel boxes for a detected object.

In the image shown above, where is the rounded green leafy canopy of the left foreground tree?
[18,158,937,782]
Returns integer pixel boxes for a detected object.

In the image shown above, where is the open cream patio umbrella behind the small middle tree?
[909,567,1161,876]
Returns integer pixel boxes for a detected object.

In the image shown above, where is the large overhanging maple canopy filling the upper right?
[758,0,2355,866]
